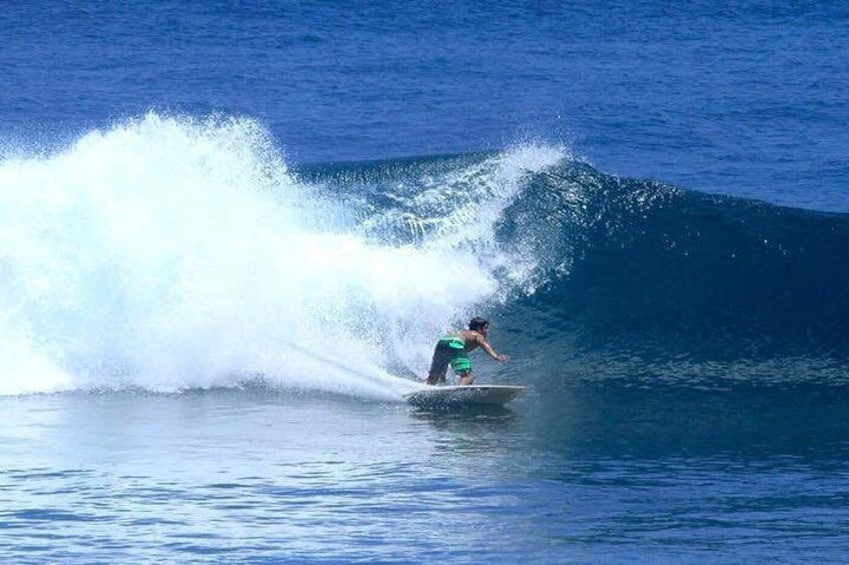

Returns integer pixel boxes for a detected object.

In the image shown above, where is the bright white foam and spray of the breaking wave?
[0,114,558,398]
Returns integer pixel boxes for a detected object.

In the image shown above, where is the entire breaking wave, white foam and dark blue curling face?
[0,114,849,399]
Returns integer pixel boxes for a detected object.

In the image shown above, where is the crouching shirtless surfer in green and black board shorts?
[425,318,510,385]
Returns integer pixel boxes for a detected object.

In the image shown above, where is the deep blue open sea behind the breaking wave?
[0,1,849,211]
